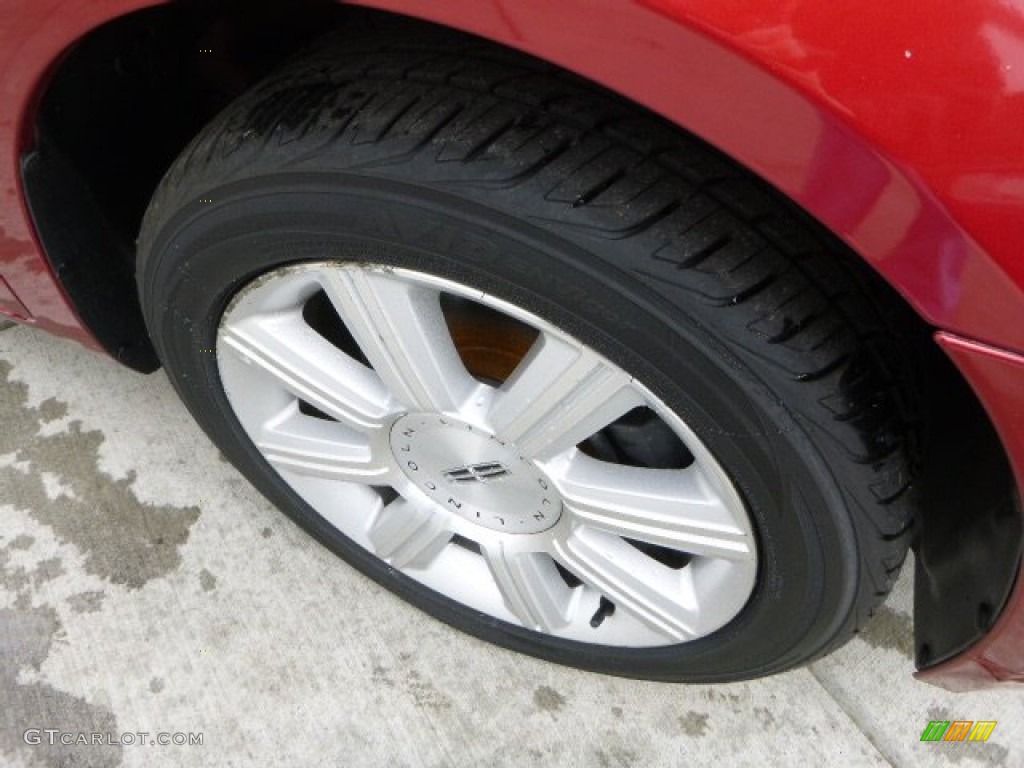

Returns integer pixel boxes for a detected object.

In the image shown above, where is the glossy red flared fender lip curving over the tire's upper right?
[354,0,1024,348]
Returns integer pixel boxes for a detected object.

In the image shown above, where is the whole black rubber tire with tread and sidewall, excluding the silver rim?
[138,27,914,682]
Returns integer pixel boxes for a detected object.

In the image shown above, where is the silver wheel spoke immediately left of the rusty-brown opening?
[323,269,476,413]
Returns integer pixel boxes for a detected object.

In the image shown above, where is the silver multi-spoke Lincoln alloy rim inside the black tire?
[216,262,757,647]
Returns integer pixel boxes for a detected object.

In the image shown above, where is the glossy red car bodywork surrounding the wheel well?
[0,0,1024,688]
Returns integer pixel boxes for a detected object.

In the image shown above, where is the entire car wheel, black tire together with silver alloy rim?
[138,27,913,681]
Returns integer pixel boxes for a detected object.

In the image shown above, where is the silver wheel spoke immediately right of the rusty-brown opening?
[489,334,643,459]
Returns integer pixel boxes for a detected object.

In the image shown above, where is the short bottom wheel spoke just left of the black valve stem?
[483,543,572,632]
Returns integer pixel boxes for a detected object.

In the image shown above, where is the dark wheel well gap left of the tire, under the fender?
[22,0,347,371]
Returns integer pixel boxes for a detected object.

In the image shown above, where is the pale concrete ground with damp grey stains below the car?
[0,319,1024,768]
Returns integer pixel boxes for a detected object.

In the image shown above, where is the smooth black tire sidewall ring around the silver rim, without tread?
[138,173,858,682]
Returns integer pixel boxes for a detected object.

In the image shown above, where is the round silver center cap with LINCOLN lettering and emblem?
[391,414,562,534]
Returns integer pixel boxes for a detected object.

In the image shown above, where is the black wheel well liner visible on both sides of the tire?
[23,0,1020,665]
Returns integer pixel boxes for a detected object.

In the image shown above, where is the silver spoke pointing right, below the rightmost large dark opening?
[555,454,754,560]
